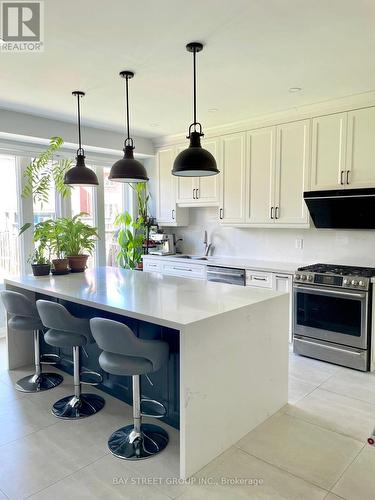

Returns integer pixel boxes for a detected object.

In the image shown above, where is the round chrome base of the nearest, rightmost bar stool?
[108,424,169,460]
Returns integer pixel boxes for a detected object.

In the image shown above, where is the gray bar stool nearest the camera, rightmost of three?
[90,318,169,460]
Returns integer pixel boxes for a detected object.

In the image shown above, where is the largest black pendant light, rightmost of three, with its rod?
[172,42,220,177]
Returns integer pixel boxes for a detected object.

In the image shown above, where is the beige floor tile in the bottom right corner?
[333,445,375,500]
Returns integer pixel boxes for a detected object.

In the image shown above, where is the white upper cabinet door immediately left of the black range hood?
[275,120,310,224]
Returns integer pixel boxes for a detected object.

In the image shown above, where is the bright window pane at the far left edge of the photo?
[0,155,20,282]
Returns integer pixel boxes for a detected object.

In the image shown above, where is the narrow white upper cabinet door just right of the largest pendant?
[219,132,245,224]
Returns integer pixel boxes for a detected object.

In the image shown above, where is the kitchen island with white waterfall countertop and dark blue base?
[5,267,289,478]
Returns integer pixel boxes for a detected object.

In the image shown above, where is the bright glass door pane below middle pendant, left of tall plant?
[103,167,127,266]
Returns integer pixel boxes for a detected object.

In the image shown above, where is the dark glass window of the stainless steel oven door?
[297,292,362,337]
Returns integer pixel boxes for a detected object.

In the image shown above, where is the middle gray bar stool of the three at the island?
[36,300,105,419]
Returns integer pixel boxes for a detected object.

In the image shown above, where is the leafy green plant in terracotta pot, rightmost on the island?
[59,212,99,273]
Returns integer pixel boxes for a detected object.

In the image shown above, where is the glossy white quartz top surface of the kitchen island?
[4,267,283,329]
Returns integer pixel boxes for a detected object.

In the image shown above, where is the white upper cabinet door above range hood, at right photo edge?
[345,107,375,188]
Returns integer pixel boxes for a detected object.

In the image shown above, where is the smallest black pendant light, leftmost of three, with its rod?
[64,90,99,186]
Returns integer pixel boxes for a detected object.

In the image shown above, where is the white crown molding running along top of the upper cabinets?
[153,90,375,148]
